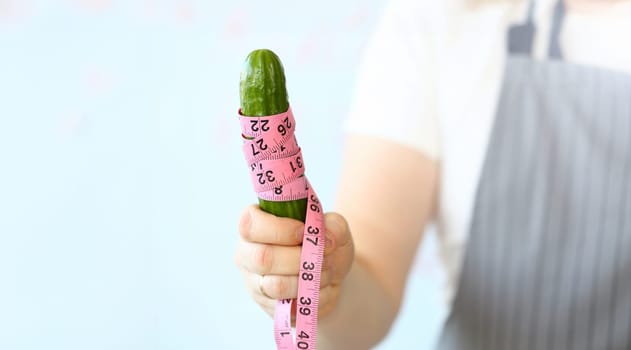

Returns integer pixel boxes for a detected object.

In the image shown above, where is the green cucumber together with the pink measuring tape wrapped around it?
[238,49,325,350]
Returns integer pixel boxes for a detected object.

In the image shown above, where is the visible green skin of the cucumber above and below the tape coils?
[239,49,307,222]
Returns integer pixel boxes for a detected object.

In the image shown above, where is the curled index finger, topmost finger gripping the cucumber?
[239,205,305,246]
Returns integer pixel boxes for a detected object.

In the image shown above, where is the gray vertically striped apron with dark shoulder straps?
[438,2,631,350]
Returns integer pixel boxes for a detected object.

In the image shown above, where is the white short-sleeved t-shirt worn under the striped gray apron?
[345,0,631,301]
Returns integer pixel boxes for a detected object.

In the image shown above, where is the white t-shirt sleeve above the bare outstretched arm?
[344,0,440,159]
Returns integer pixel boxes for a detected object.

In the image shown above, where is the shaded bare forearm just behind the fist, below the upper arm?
[318,254,399,349]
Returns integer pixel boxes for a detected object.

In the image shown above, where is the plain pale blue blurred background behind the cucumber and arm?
[0,0,445,350]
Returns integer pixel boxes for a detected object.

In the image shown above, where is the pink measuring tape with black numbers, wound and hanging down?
[239,107,325,350]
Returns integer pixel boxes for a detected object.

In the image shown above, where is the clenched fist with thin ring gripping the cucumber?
[236,205,354,317]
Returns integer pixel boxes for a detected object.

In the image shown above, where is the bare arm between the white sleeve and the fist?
[318,135,438,350]
